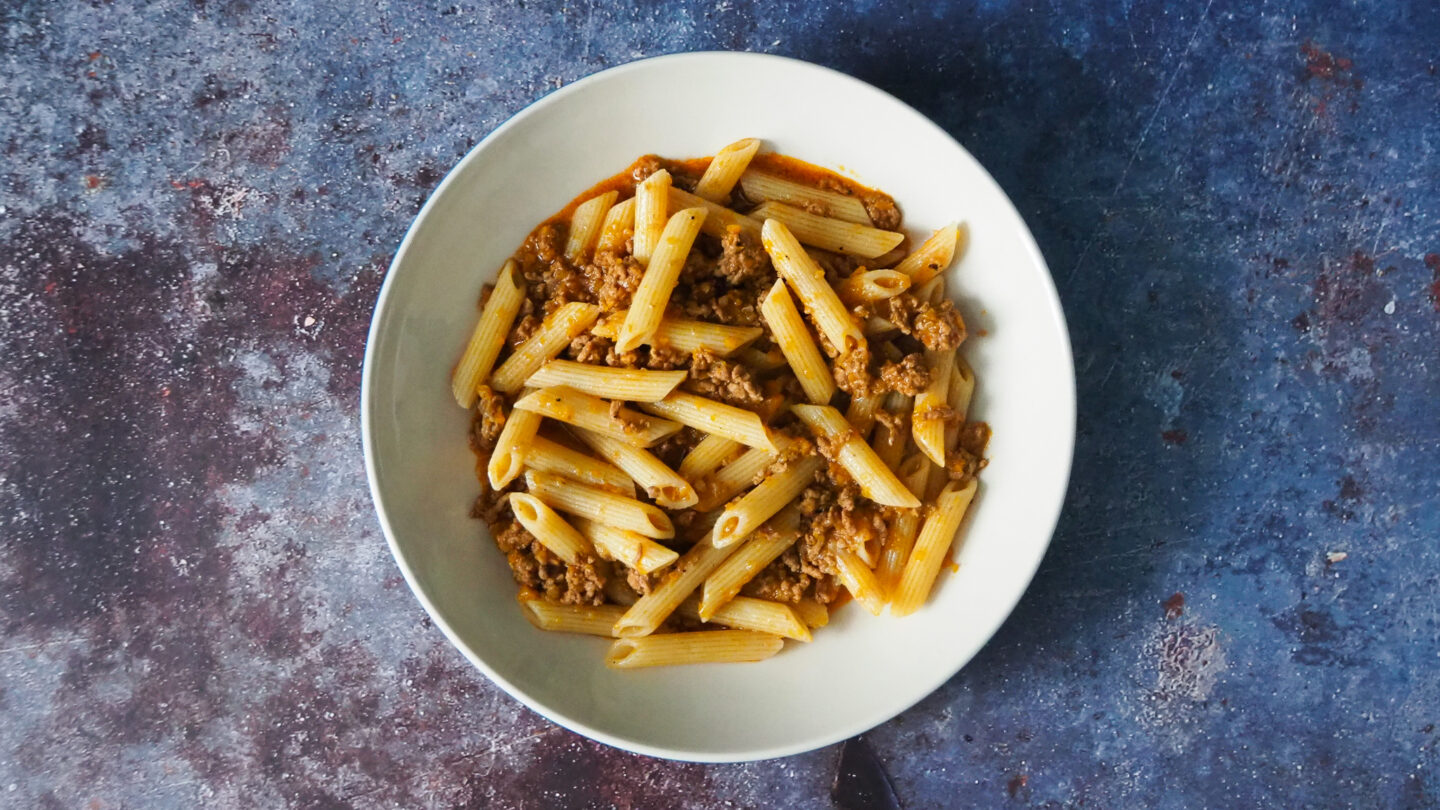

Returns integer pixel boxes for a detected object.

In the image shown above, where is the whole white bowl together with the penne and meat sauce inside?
[361,53,1074,761]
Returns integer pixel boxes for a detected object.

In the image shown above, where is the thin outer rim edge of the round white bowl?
[360,50,1077,762]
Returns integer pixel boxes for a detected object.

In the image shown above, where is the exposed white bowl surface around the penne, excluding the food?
[361,53,1076,762]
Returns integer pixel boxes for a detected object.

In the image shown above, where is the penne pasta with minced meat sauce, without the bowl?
[451,138,989,669]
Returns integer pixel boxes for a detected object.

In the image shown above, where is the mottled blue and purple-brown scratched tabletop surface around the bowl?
[0,0,1440,809]
